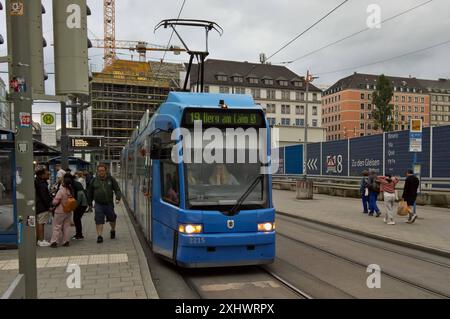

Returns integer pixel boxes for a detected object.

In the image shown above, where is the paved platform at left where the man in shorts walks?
[0,203,158,299]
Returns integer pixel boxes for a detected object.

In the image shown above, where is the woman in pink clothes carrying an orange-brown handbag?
[50,174,77,248]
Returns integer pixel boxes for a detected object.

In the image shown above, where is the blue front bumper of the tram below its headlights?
[176,231,275,268]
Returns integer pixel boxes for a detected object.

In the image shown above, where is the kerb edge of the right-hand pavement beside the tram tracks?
[276,210,450,258]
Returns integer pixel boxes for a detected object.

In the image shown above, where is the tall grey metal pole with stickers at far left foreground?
[6,0,37,299]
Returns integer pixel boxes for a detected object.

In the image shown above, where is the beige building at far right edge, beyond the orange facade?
[419,79,450,126]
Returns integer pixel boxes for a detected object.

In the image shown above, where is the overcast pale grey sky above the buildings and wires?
[0,0,450,127]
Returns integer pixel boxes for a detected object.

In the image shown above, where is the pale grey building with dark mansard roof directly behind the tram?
[191,59,322,128]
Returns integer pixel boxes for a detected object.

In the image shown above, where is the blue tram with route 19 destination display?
[121,92,275,267]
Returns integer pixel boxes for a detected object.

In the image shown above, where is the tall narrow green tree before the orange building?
[372,74,394,132]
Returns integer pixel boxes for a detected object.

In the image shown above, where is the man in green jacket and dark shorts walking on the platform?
[88,164,122,243]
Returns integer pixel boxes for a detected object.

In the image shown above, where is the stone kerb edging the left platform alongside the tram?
[121,201,159,299]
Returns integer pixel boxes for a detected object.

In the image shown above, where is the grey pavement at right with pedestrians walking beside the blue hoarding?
[273,190,450,257]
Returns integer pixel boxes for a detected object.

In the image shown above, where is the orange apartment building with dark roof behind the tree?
[322,73,430,141]
